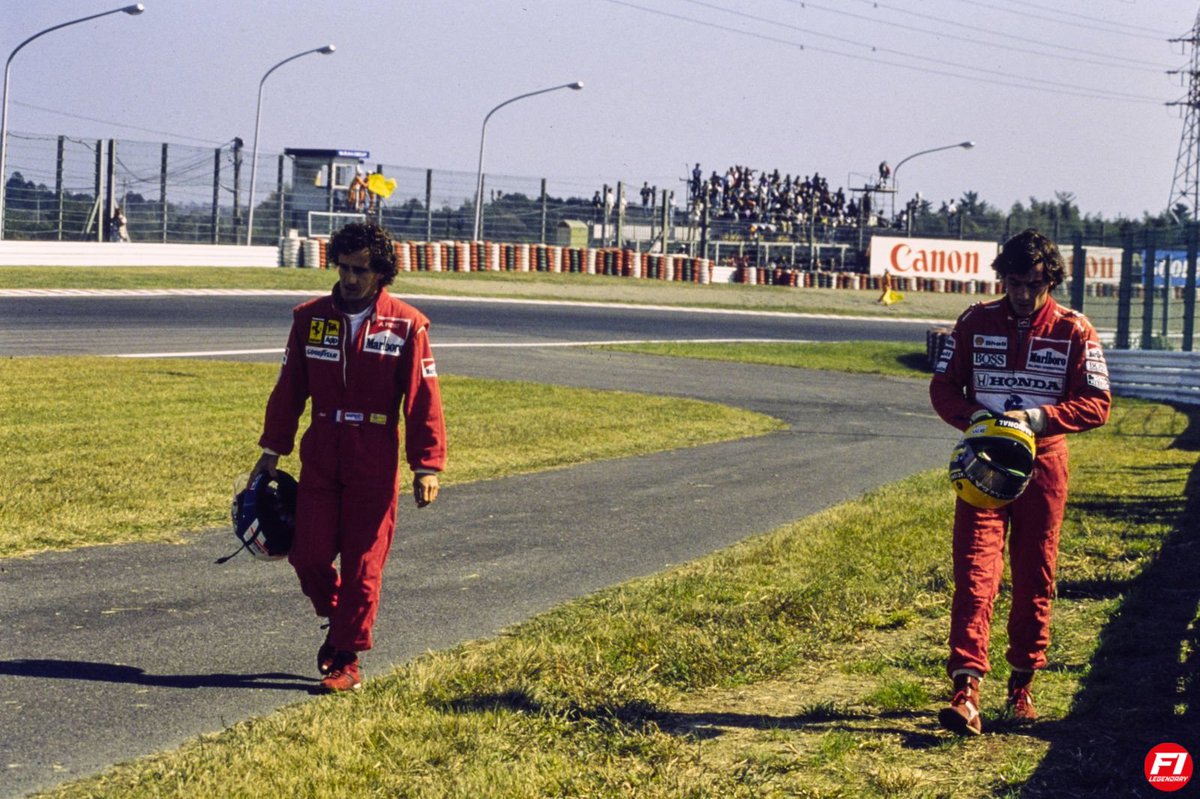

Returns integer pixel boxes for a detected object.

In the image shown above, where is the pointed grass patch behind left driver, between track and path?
[0,358,780,557]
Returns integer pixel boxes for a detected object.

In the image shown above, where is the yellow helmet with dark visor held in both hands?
[950,416,1037,507]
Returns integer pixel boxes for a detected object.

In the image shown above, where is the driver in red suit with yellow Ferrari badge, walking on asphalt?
[251,223,446,691]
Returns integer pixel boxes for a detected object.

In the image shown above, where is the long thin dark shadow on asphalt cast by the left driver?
[0,660,317,691]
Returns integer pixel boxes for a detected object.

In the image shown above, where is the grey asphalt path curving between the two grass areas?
[0,348,956,798]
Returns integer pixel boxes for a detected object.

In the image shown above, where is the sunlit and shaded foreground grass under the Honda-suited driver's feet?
[39,401,1200,798]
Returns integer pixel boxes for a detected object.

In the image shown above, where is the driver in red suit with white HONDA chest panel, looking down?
[929,229,1111,734]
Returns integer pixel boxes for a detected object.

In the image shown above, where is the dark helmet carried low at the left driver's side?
[217,469,296,563]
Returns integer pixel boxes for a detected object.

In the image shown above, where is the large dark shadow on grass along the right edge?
[1020,410,1200,799]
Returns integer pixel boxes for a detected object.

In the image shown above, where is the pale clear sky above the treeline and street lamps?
[0,0,1200,217]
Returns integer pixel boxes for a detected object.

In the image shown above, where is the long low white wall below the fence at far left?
[0,241,280,266]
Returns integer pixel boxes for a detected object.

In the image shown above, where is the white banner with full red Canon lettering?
[871,236,1000,281]
